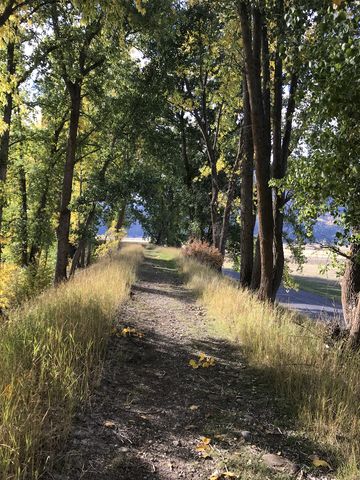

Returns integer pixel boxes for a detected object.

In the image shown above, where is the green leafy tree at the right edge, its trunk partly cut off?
[285,2,360,346]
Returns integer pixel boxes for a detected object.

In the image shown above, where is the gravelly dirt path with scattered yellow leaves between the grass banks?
[49,253,332,480]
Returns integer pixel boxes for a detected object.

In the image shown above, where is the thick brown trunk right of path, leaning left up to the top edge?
[239,2,274,300]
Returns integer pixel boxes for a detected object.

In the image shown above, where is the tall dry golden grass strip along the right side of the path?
[181,259,360,480]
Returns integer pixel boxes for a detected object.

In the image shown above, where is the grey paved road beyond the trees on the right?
[223,268,343,323]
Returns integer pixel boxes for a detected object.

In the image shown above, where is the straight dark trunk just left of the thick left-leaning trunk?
[240,75,256,287]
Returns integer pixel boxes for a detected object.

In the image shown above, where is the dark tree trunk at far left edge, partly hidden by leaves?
[0,42,15,261]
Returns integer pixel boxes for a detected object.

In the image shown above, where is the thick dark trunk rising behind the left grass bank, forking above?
[55,82,81,283]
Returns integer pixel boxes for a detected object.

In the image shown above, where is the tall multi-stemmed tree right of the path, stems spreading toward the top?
[237,0,315,300]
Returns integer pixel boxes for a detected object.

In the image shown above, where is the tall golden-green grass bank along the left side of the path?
[0,247,142,480]
